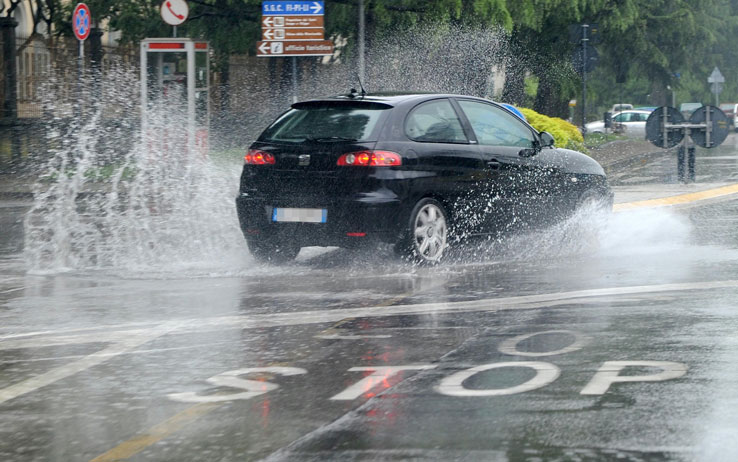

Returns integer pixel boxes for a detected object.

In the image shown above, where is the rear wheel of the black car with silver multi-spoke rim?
[395,198,449,264]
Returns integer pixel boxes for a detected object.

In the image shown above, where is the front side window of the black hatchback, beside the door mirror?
[459,100,535,148]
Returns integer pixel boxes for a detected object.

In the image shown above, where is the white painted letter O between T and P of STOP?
[434,361,561,397]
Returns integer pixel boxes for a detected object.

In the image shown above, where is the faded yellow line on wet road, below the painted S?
[90,403,218,462]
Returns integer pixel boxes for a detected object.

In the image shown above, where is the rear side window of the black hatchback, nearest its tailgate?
[405,99,468,143]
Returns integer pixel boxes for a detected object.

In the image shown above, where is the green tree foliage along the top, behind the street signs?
[41,0,738,122]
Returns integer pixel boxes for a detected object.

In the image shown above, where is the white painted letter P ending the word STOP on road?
[579,361,687,395]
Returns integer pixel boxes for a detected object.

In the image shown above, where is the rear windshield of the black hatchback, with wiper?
[259,101,392,143]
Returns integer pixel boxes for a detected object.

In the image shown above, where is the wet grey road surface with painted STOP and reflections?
[0,136,738,461]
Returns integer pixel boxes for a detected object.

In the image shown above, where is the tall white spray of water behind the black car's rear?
[25,65,243,272]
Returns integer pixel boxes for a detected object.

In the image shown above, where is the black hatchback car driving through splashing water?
[236,92,612,262]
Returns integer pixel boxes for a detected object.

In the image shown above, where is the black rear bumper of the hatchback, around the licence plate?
[236,194,406,247]
